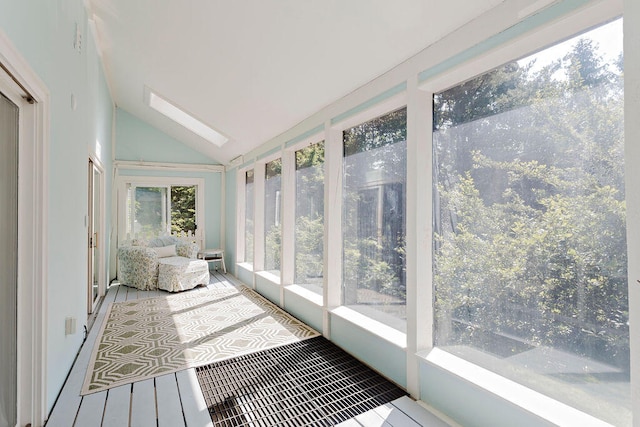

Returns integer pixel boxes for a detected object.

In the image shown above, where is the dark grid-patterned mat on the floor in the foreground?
[196,336,406,427]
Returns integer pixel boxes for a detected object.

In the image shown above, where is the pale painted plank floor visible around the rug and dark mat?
[46,271,448,427]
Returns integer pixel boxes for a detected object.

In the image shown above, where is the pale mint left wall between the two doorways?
[0,0,113,410]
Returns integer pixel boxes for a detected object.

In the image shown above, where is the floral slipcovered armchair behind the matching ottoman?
[118,236,199,290]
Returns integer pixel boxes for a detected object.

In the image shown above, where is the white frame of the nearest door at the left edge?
[0,30,51,426]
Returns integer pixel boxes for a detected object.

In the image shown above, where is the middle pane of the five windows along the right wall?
[294,141,324,295]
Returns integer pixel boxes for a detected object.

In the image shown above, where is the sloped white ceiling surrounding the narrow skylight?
[89,0,503,164]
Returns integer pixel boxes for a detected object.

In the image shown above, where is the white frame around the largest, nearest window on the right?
[418,2,628,425]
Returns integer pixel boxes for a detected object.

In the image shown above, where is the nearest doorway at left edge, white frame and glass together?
[0,37,50,427]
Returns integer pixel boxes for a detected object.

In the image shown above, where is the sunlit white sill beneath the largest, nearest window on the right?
[417,348,610,427]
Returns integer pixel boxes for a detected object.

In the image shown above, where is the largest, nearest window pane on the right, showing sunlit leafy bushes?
[433,21,631,425]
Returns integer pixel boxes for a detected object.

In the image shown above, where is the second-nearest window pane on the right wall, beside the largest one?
[342,108,407,331]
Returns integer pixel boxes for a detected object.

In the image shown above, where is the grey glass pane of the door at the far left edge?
[0,93,19,426]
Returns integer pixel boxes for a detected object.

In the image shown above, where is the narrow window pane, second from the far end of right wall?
[264,159,282,276]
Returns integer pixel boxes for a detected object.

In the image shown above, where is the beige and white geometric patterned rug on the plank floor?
[81,286,319,395]
